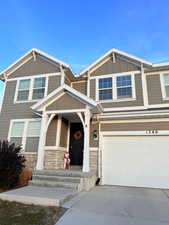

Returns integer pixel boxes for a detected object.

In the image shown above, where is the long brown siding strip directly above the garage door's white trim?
[101,122,169,131]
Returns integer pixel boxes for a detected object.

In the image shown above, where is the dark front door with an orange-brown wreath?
[69,123,84,165]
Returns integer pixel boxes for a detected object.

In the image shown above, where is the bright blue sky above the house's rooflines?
[0,0,169,101]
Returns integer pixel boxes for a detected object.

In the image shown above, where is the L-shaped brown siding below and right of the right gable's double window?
[101,74,143,108]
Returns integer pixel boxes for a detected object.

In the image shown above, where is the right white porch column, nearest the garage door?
[83,107,91,172]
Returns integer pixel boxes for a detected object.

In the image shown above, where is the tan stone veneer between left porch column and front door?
[44,150,65,170]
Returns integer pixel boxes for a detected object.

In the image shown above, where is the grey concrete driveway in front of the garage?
[57,186,169,225]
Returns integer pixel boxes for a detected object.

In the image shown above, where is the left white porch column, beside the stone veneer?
[36,112,49,170]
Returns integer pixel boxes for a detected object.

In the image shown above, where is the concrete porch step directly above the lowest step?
[33,175,80,183]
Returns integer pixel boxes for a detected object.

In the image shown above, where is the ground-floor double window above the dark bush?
[9,119,41,152]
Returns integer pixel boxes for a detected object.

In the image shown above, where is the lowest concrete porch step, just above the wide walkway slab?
[29,180,78,190]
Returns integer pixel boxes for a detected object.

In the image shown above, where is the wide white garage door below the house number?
[102,136,169,188]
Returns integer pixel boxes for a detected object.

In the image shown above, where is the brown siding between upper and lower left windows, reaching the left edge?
[0,81,38,139]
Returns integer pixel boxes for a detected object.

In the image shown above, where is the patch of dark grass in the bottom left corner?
[0,200,66,225]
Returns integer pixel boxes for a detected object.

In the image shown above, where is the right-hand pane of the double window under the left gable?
[32,77,46,99]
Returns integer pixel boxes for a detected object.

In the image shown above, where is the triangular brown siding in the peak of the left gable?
[9,56,59,78]
